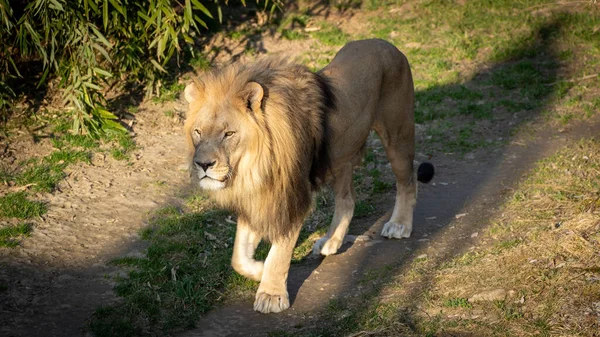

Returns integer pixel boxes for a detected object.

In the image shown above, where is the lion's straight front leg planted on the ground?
[254,226,300,314]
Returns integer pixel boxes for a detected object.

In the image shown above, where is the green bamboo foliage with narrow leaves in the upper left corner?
[0,0,279,135]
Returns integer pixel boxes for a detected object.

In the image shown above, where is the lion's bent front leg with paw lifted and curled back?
[231,217,264,281]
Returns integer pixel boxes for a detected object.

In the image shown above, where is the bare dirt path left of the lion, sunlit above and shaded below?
[0,111,186,336]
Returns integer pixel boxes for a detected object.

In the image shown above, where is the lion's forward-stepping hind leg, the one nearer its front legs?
[313,163,355,256]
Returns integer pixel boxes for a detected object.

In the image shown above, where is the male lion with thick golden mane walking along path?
[184,39,433,313]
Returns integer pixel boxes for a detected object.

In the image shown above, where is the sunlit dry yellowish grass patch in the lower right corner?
[436,139,600,336]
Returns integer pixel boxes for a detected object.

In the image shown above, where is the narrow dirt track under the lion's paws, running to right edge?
[181,116,600,337]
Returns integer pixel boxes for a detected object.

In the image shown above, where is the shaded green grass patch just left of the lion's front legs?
[90,209,235,336]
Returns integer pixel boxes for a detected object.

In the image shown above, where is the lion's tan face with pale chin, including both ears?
[185,79,262,191]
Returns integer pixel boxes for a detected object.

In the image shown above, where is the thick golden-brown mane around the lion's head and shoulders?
[187,57,335,241]
